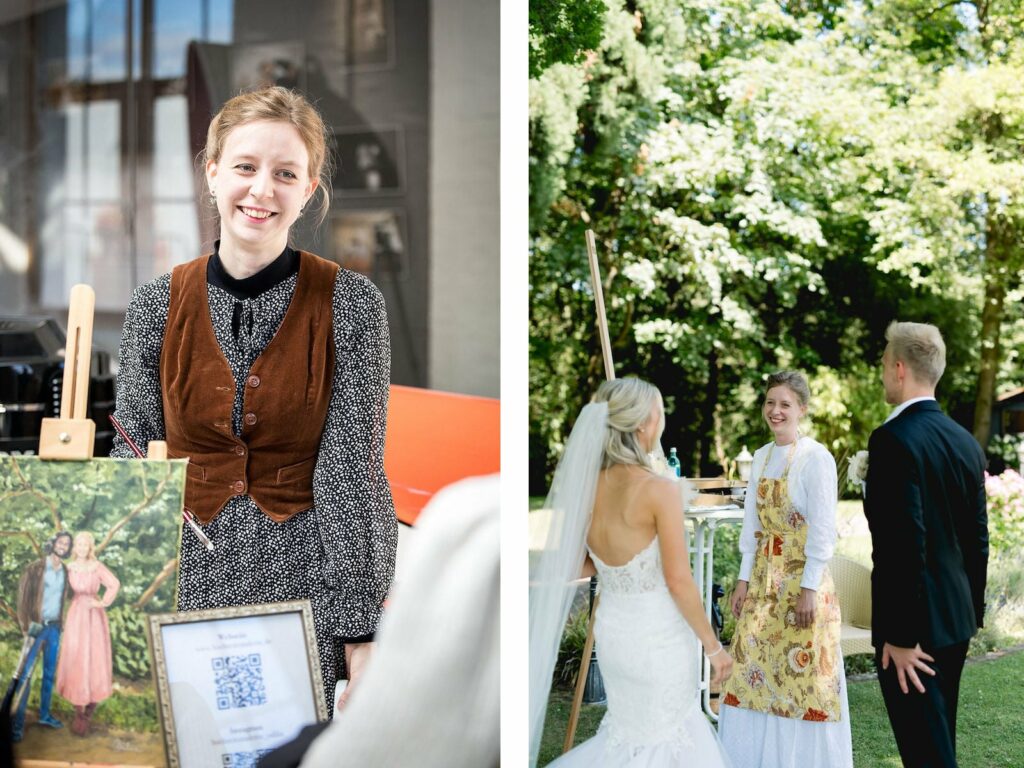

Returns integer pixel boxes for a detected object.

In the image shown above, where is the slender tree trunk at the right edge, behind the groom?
[973,214,1013,447]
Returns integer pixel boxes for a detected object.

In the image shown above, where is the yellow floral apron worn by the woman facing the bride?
[722,441,840,722]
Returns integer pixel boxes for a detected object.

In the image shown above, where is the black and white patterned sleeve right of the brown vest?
[313,269,398,642]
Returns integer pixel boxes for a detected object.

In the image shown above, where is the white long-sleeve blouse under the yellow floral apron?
[739,437,839,590]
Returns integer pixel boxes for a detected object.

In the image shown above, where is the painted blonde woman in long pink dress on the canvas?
[57,531,121,736]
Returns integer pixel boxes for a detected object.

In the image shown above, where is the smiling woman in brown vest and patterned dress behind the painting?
[113,87,397,710]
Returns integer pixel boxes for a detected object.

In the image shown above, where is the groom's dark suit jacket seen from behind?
[864,400,988,648]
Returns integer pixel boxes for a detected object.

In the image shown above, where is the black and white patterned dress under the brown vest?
[111,249,397,711]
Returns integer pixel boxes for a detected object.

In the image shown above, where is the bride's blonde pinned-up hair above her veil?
[594,378,665,469]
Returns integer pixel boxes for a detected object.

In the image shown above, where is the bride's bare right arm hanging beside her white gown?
[647,478,721,655]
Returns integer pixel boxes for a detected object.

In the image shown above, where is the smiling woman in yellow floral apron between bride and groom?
[719,372,853,768]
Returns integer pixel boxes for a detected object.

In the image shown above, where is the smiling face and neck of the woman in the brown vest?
[206,120,317,258]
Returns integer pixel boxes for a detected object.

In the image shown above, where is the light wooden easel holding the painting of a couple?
[12,284,161,768]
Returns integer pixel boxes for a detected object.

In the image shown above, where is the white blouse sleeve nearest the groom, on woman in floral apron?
[794,445,839,590]
